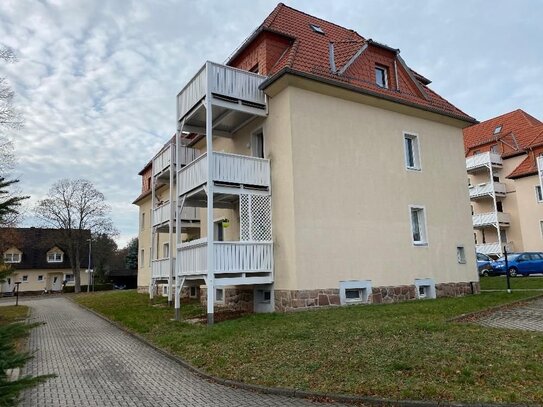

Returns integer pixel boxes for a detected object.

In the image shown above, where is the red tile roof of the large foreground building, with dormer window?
[228,3,476,123]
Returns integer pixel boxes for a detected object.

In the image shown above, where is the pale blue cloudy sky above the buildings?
[0,0,543,245]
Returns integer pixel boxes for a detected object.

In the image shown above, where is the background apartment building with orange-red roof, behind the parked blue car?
[464,109,543,257]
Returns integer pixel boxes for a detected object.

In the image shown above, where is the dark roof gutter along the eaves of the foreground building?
[259,67,479,124]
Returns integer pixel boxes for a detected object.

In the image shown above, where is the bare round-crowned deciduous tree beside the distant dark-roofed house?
[35,179,116,292]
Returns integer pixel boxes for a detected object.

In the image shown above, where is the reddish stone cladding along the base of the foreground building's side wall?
[275,282,480,312]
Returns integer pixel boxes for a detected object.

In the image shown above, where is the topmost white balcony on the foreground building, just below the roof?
[177,62,267,135]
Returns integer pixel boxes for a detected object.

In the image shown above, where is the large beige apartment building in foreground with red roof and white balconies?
[138,4,478,322]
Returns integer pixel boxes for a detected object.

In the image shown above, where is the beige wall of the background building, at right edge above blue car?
[514,175,543,251]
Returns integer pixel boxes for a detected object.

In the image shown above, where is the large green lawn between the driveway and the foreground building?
[75,292,543,404]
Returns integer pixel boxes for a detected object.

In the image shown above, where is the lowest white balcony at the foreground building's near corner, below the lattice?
[177,238,273,285]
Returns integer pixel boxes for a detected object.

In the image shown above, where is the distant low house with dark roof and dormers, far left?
[0,228,90,293]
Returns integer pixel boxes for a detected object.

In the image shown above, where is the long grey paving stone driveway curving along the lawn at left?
[21,297,348,407]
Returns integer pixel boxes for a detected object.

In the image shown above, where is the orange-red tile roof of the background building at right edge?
[464,109,543,178]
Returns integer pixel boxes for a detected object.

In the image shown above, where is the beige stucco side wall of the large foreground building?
[280,87,477,289]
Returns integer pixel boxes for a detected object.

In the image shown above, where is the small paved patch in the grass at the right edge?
[478,298,543,332]
